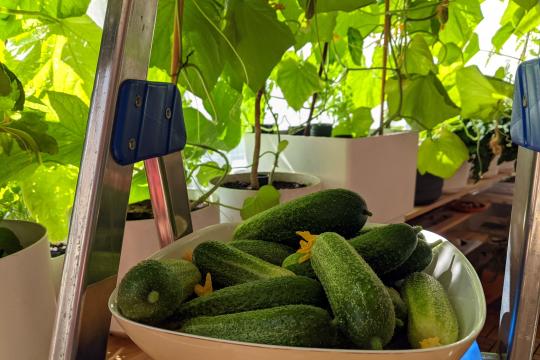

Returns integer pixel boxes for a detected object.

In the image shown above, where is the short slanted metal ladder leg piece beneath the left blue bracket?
[144,152,193,247]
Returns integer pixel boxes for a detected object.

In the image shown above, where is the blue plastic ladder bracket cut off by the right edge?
[510,59,540,151]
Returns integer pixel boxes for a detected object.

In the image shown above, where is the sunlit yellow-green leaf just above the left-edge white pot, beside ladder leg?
[21,165,78,243]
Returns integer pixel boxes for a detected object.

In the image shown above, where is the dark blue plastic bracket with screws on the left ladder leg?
[111,80,186,165]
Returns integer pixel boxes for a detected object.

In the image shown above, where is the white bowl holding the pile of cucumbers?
[109,224,486,360]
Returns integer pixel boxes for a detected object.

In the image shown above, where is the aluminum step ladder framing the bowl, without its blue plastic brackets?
[49,0,540,360]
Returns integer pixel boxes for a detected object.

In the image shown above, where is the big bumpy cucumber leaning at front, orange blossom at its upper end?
[311,233,395,349]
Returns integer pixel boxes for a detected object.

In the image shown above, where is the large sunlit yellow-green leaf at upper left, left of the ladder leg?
[4,15,101,103]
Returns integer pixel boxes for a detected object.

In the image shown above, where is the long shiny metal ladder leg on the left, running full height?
[49,0,157,360]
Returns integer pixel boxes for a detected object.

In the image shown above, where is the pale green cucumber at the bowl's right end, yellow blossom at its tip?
[401,272,459,349]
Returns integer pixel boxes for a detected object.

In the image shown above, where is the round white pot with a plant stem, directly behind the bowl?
[211,172,321,223]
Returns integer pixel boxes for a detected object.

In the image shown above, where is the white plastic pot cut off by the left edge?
[0,220,56,360]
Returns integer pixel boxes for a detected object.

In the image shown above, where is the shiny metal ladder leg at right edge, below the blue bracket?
[499,147,540,360]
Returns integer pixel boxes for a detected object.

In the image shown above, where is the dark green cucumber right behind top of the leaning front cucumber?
[350,223,418,275]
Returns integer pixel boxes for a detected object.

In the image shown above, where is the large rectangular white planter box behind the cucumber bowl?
[245,132,418,223]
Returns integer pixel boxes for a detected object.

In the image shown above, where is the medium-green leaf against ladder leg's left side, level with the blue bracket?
[47,91,88,166]
